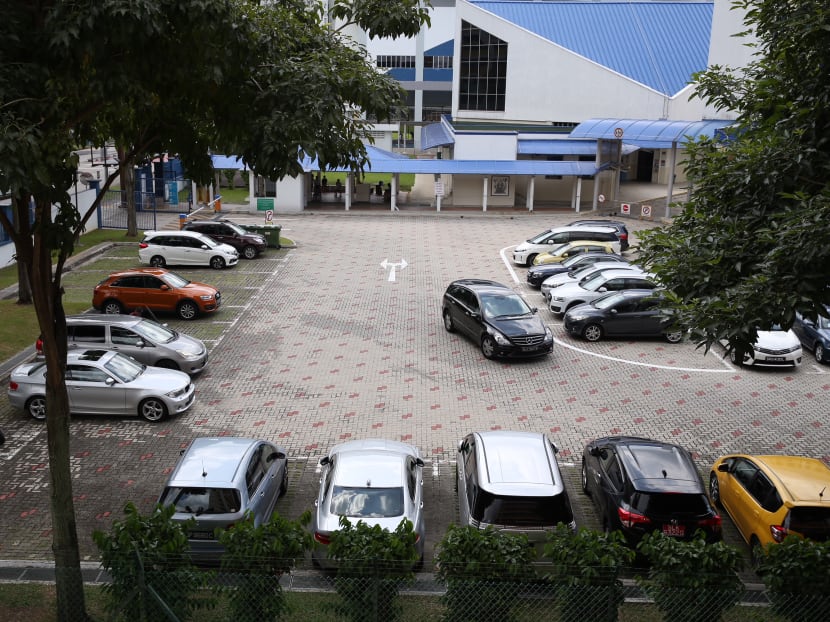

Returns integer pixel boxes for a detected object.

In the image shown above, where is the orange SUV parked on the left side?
[92,268,222,320]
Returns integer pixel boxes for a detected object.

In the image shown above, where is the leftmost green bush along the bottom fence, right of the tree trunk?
[92,503,215,621]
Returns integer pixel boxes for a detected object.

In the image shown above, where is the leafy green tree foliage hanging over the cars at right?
[642,0,830,353]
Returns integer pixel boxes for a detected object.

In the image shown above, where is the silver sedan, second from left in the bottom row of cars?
[312,439,425,568]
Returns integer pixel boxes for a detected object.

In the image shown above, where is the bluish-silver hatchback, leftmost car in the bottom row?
[159,436,288,563]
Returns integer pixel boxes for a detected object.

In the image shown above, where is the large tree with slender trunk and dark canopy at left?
[0,0,427,620]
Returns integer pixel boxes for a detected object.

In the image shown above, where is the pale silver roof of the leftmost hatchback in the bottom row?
[167,436,268,487]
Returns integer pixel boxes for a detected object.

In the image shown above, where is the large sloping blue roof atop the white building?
[471,0,714,96]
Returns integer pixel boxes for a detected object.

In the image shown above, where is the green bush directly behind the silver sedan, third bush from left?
[328,516,419,622]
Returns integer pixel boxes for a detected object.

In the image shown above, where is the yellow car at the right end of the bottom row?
[709,454,830,556]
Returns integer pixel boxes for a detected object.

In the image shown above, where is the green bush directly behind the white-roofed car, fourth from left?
[435,525,536,622]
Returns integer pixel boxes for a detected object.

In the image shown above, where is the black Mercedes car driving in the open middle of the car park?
[441,279,553,359]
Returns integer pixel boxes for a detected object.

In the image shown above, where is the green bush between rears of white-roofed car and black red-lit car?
[544,524,634,622]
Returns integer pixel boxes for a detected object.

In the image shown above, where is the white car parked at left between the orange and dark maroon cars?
[138,231,239,270]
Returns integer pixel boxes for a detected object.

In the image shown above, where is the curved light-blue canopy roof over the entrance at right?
[571,119,734,149]
